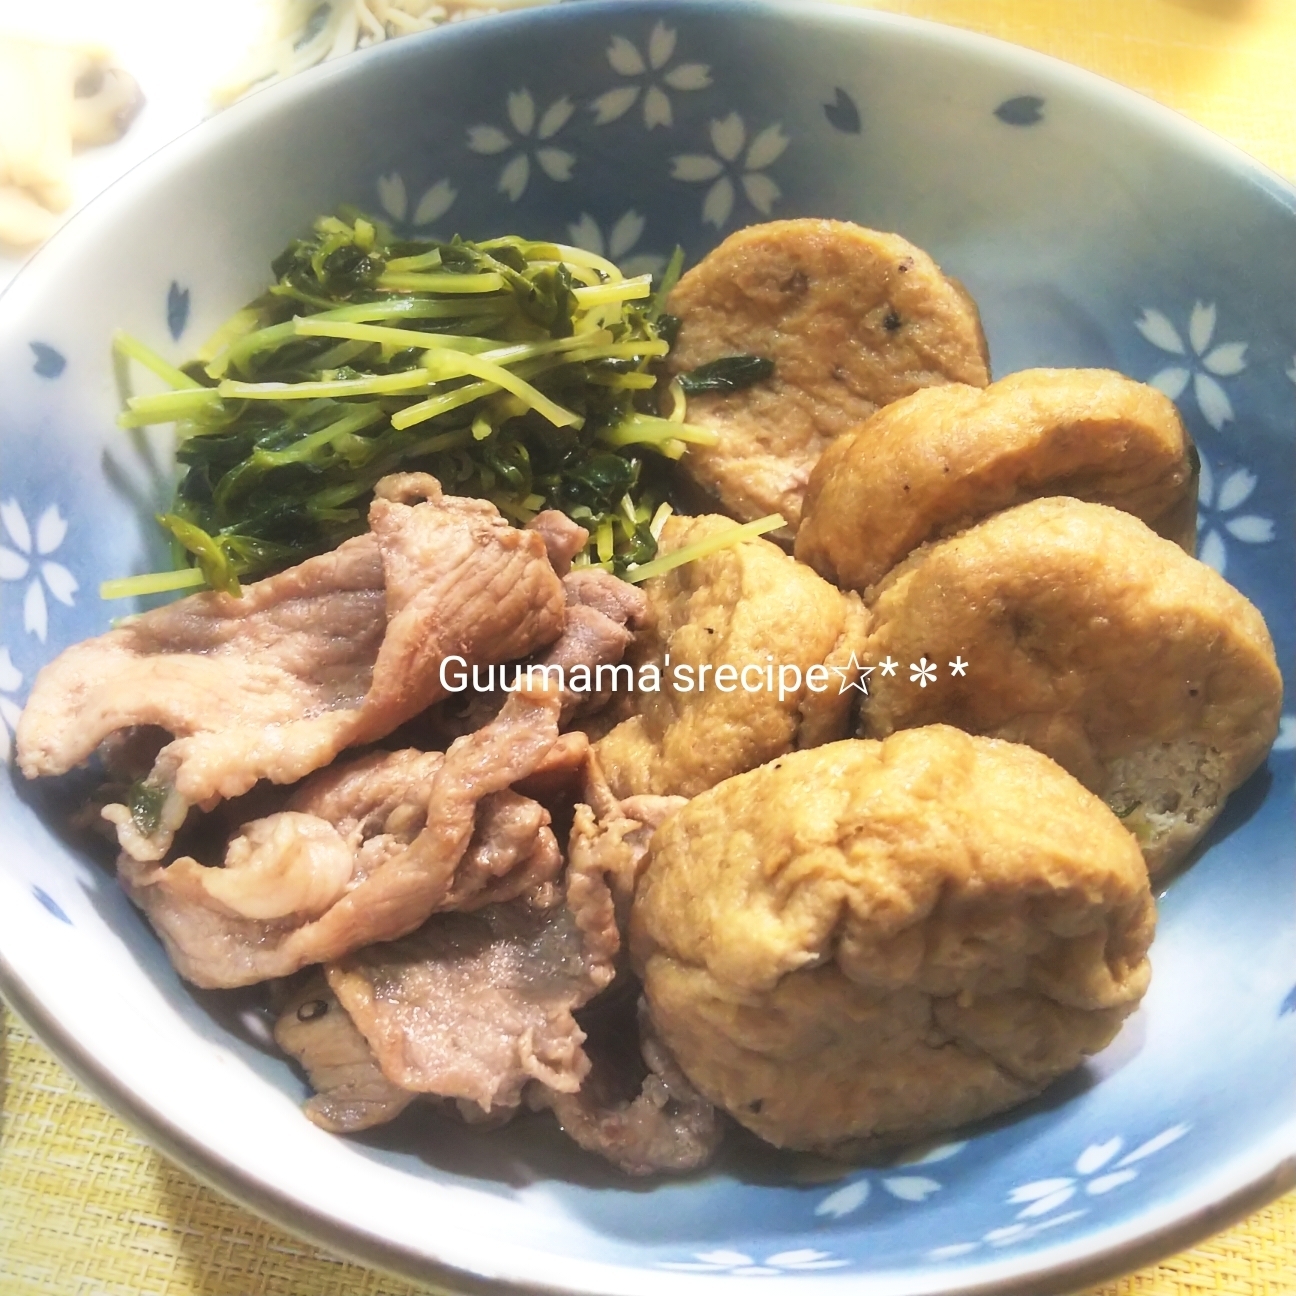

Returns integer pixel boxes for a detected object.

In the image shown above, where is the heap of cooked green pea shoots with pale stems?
[104,213,741,597]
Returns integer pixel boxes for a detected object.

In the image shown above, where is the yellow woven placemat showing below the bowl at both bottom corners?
[0,1006,1296,1296]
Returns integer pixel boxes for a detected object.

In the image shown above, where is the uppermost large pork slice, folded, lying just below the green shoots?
[17,473,565,861]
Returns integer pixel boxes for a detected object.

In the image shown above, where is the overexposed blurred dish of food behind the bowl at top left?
[0,0,548,273]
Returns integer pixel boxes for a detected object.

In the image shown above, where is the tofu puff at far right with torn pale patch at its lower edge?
[864,499,1282,871]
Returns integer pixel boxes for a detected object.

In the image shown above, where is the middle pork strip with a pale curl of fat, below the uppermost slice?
[118,691,561,988]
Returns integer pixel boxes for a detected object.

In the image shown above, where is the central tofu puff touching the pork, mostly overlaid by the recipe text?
[595,516,864,797]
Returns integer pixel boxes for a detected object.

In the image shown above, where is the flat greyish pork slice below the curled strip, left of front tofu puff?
[327,898,619,1111]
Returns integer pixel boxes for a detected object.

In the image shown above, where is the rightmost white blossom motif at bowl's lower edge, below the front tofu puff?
[927,1124,1191,1260]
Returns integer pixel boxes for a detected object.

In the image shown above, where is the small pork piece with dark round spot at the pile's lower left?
[275,972,417,1134]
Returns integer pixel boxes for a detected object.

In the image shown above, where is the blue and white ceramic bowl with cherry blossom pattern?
[0,0,1296,1296]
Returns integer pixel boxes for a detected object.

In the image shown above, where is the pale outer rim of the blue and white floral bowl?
[0,0,1296,1296]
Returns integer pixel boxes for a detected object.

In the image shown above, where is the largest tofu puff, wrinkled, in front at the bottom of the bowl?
[631,726,1155,1152]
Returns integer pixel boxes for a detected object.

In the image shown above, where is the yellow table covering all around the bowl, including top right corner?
[0,0,1296,1296]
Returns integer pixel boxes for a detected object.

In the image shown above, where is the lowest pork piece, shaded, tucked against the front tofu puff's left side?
[527,991,724,1174]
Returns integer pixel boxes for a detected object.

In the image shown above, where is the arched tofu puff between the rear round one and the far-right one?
[797,369,1198,590]
